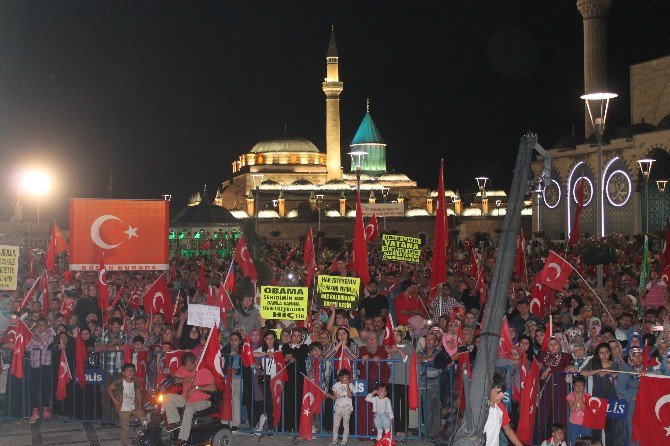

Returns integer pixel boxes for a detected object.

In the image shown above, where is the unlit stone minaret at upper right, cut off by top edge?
[577,0,612,138]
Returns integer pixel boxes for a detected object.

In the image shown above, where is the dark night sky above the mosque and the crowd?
[0,0,670,226]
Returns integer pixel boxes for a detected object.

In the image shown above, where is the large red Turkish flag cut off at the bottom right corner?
[632,375,670,446]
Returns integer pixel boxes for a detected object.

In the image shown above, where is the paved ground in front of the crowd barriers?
[0,420,432,446]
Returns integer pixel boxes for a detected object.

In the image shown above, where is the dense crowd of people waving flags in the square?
[0,232,670,446]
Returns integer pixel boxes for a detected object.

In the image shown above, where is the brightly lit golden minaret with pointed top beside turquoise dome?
[323,26,343,180]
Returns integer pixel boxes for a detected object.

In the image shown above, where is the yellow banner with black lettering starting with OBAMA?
[261,286,308,321]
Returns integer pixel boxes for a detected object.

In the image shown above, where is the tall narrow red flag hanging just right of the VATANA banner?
[428,160,449,300]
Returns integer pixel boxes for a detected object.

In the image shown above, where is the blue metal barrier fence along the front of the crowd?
[4,350,629,445]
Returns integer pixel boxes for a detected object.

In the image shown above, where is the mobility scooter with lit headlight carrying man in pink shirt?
[133,376,232,446]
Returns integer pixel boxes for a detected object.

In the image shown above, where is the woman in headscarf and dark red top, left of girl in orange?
[539,336,572,433]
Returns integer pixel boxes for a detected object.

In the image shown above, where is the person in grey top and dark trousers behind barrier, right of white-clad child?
[385,325,413,436]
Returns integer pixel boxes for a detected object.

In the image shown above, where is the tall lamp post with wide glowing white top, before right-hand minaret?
[580,92,619,293]
